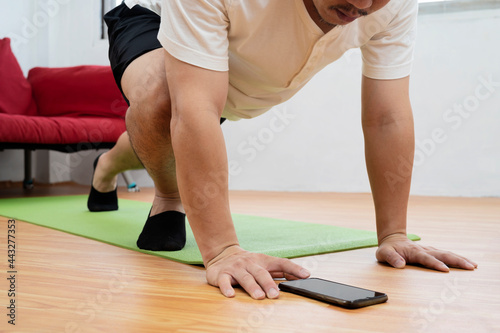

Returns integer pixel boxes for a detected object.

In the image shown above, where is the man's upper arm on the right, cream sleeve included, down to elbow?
[361,0,418,127]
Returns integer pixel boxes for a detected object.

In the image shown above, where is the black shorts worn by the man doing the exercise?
[104,3,162,103]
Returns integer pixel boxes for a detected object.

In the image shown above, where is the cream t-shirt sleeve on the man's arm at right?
[361,0,418,80]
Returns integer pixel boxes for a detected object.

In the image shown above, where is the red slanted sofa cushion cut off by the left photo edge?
[0,38,36,115]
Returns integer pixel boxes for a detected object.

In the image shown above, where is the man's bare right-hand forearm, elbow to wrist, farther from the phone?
[363,115,415,243]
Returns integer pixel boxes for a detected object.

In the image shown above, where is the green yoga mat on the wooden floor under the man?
[0,195,420,264]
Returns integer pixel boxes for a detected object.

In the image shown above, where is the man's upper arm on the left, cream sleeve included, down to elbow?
[158,0,229,118]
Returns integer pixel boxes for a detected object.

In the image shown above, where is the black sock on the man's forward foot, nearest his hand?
[137,210,186,251]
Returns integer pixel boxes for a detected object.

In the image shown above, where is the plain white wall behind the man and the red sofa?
[0,0,500,196]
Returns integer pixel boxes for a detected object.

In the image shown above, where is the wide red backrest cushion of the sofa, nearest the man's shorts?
[28,66,127,118]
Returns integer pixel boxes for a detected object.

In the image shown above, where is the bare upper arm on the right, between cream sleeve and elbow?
[361,76,412,126]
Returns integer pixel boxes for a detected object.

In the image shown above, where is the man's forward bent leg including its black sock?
[121,49,185,251]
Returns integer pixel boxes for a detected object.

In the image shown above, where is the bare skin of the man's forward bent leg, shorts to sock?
[122,49,184,216]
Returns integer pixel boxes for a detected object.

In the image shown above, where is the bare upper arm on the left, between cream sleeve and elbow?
[164,51,229,119]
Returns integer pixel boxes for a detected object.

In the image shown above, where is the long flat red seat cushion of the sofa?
[0,113,125,144]
